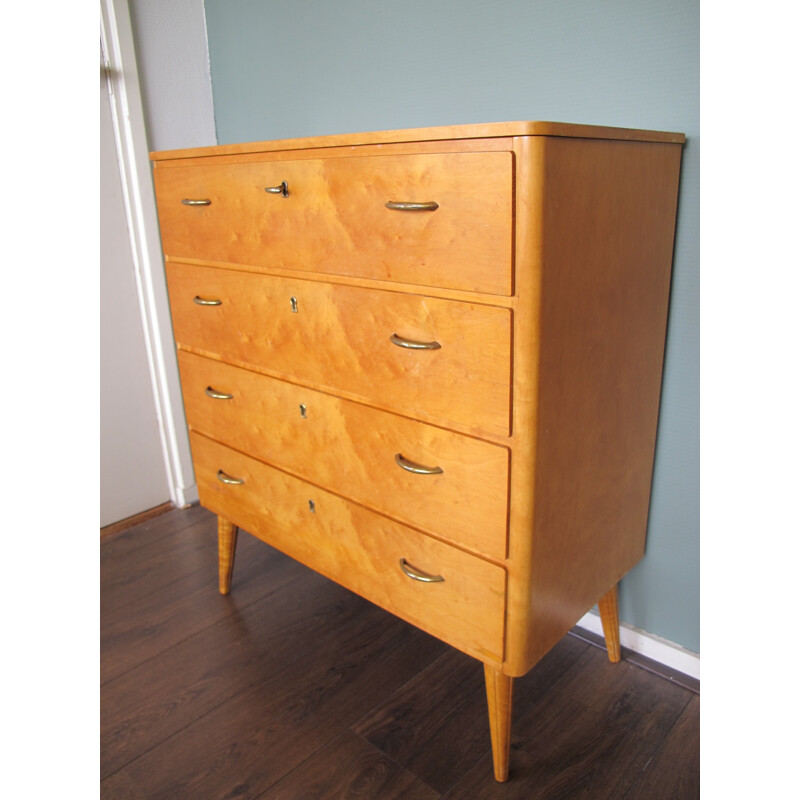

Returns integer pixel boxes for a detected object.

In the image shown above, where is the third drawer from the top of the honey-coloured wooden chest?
[178,351,509,560]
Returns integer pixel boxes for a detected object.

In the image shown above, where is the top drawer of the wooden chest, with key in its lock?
[154,152,513,295]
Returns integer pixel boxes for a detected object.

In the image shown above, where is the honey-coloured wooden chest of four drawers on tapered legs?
[152,122,684,780]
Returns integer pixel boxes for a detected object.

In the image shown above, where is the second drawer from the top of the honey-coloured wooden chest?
[167,263,511,436]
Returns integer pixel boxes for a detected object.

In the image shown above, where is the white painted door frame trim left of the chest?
[100,0,197,507]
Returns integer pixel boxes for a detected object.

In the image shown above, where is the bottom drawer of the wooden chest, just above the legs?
[190,433,505,662]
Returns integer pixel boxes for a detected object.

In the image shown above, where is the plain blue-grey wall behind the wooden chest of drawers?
[205,0,700,652]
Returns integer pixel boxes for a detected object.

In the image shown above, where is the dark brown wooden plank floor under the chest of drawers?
[101,506,700,800]
